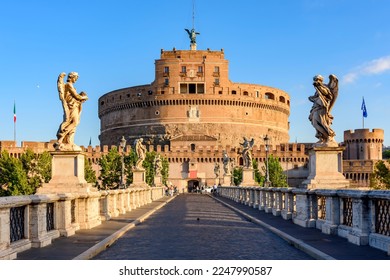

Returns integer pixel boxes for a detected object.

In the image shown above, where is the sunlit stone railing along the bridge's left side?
[0,187,164,260]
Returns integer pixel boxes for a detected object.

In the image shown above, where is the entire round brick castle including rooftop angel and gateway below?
[99,29,307,188]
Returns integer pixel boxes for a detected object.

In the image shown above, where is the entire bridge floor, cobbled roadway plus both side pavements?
[18,194,390,260]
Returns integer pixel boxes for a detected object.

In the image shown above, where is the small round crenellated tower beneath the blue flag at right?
[343,128,384,160]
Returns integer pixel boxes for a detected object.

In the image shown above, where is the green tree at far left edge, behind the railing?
[0,151,30,196]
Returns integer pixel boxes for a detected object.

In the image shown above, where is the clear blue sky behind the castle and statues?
[0,0,390,146]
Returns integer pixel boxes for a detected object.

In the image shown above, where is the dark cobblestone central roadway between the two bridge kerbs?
[94,194,312,260]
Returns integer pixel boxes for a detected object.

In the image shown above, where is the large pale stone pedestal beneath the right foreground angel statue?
[301,146,350,189]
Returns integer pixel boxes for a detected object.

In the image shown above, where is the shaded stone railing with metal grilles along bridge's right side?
[218,187,390,255]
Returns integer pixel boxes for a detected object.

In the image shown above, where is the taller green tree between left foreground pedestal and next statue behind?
[99,147,122,190]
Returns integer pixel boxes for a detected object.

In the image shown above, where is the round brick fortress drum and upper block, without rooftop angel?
[99,49,290,146]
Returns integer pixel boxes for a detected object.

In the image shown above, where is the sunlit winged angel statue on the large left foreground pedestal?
[54,72,88,151]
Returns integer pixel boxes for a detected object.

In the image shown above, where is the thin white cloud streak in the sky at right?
[343,56,390,84]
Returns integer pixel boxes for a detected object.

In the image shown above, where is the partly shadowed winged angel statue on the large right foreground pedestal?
[309,74,338,146]
